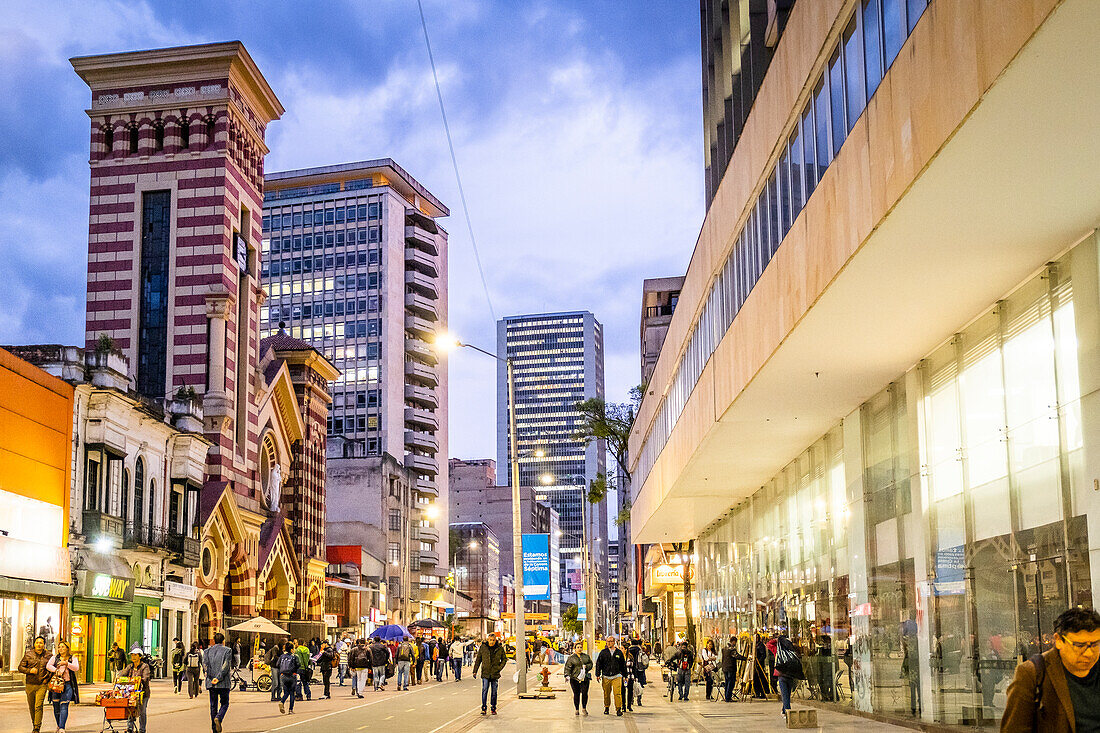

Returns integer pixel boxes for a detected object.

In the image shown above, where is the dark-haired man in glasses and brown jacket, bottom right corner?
[1001,609,1100,733]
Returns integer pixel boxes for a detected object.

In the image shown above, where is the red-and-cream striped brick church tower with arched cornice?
[72,42,283,627]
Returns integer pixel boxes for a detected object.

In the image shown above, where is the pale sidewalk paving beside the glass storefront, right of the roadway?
[462,677,908,733]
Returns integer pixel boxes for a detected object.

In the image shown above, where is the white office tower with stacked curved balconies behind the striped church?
[261,158,449,587]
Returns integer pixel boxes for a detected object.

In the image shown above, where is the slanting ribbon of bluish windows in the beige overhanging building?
[635,0,927,493]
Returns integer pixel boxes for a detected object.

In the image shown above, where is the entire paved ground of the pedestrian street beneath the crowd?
[0,665,904,733]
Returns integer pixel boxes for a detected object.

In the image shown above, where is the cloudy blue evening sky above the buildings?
[0,0,704,459]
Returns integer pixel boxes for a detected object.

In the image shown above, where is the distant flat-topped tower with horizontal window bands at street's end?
[496,311,607,603]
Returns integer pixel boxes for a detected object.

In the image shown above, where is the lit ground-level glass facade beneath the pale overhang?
[697,246,1096,725]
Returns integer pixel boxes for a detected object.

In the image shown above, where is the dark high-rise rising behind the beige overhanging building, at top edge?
[699,0,795,207]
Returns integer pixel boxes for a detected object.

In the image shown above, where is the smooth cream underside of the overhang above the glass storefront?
[631,0,1100,543]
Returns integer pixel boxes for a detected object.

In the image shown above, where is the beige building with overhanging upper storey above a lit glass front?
[629,0,1100,730]
